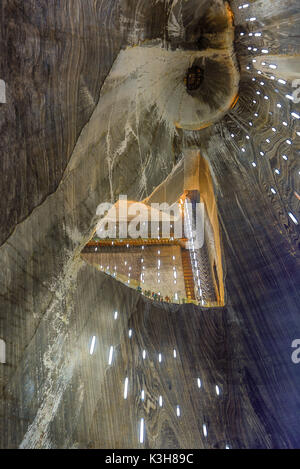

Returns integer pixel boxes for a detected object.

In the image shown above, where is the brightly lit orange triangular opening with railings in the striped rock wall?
[81,152,224,307]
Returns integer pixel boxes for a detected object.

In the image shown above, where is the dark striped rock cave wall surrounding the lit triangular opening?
[0,0,300,448]
